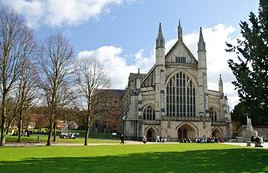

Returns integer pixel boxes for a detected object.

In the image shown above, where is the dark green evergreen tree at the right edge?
[227,0,268,125]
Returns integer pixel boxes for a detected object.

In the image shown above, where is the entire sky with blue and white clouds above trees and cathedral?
[0,0,258,109]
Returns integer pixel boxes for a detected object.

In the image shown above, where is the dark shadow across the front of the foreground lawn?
[0,149,268,173]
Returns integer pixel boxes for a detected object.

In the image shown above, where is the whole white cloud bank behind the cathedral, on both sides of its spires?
[78,24,238,107]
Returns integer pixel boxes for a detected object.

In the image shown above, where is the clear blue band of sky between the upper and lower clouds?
[33,0,258,56]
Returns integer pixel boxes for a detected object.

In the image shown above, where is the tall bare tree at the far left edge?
[0,11,32,146]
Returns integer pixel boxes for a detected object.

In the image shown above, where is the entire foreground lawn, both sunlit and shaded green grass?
[0,144,268,173]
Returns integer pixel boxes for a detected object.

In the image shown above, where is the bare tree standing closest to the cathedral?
[77,57,110,145]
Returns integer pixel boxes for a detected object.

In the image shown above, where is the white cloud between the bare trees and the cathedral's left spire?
[78,46,154,89]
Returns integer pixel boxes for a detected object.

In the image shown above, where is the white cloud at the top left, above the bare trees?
[0,0,129,27]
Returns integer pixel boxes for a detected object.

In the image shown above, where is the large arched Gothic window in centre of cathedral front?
[166,72,196,117]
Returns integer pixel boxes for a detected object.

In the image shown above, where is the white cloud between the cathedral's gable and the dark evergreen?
[183,24,239,108]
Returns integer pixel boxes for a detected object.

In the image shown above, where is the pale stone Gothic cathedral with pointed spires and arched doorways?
[123,23,232,141]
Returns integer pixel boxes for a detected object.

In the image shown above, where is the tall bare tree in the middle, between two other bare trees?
[40,34,73,146]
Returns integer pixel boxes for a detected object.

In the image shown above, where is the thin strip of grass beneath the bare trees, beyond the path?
[6,135,119,144]
